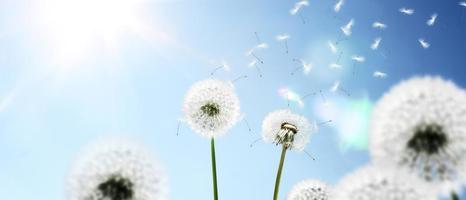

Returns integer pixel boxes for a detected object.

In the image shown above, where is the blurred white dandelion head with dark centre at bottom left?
[67,139,168,200]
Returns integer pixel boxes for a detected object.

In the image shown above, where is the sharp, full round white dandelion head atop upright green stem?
[183,79,240,138]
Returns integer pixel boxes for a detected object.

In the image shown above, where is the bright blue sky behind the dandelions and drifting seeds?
[0,0,466,200]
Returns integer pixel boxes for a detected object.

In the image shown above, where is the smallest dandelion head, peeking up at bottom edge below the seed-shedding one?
[286,180,331,200]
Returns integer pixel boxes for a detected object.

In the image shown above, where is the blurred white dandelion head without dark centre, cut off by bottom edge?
[334,165,437,200]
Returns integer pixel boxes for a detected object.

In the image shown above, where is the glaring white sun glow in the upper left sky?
[34,0,151,64]
